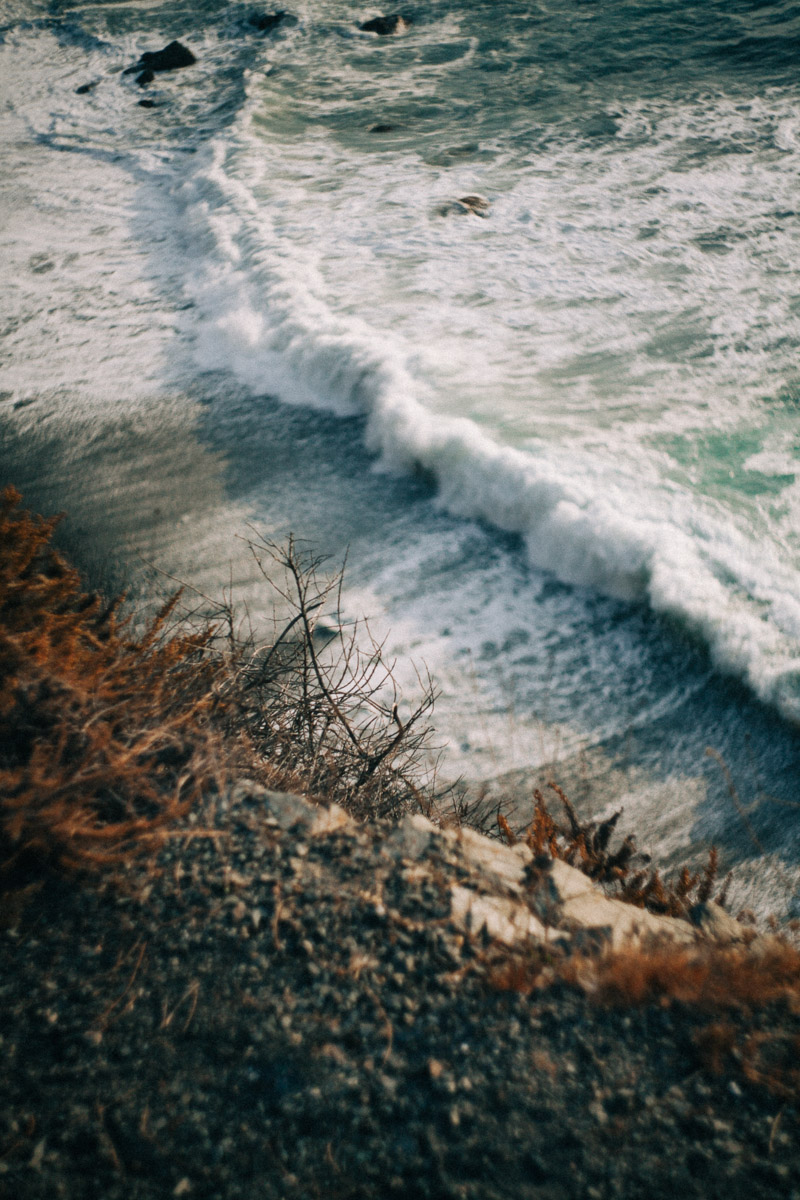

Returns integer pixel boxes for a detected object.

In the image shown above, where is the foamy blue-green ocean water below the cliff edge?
[0,0,800,918]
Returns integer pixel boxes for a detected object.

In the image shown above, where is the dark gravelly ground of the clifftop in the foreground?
[0,786,800,1200]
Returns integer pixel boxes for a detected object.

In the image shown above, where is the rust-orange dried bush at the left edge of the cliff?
[0,487,227,890]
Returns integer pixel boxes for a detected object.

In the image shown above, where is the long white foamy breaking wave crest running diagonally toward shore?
[178,143,800,721]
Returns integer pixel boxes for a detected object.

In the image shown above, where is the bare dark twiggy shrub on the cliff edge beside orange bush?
[231,539,435,820]
